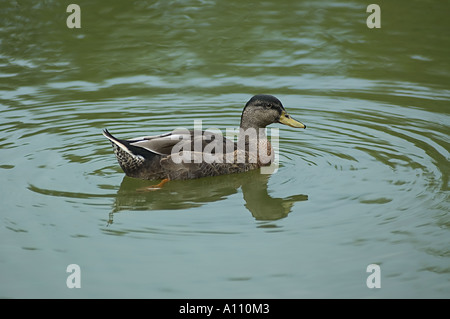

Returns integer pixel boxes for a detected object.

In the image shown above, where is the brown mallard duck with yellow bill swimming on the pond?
[103,95,306,183]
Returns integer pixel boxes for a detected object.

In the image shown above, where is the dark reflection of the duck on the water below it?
[108,170,308,224]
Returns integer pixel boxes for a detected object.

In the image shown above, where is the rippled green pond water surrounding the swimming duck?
[0,1,450,298]
